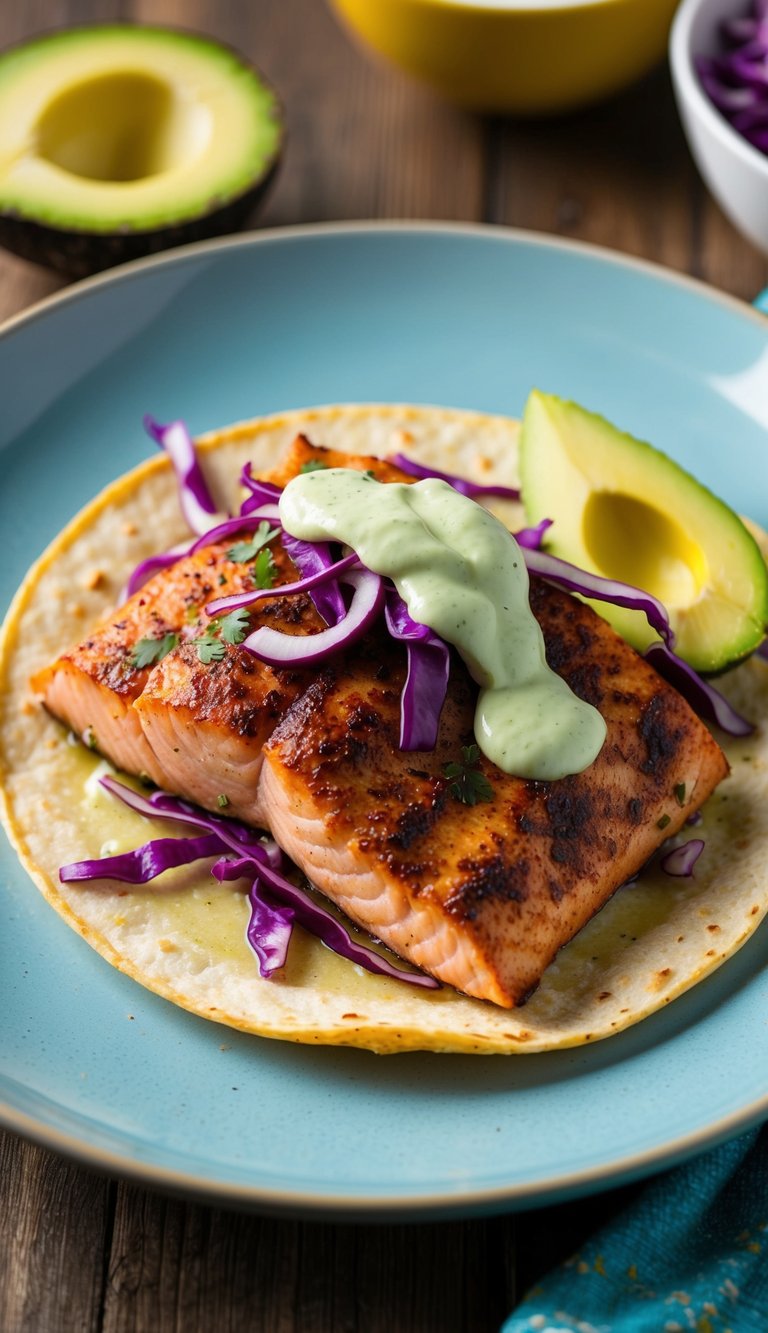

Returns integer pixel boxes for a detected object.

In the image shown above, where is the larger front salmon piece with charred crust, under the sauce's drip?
[261,580,728,1006]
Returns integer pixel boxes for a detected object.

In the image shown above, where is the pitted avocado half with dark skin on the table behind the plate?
[0,24,283,277]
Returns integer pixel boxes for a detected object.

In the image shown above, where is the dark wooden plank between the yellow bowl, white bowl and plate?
[487,68,768,300]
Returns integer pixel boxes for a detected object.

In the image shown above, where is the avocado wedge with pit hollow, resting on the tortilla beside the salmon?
[520,391,768,672]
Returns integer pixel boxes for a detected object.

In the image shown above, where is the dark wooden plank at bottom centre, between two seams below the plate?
[103,1185,512,1333]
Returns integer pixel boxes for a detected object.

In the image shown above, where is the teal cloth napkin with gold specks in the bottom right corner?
[503,1125,768,1333]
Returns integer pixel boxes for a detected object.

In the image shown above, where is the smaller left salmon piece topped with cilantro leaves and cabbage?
[31,435,402,799]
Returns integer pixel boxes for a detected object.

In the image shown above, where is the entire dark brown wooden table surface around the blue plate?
[0,0,768,1333]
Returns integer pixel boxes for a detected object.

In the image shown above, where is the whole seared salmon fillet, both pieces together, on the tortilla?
[33,437,728,1008]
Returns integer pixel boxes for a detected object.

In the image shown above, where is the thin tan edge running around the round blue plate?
[0,219,768,1221]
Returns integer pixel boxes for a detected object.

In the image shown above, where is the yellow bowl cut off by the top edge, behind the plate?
[329,0,677,115]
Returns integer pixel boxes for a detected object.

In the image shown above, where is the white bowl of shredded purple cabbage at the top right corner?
[669,0,768,253]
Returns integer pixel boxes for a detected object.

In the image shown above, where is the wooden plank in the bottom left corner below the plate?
[0,1133,115,1333]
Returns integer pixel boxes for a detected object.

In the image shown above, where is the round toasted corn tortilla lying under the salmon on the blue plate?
[0,405,768,1054]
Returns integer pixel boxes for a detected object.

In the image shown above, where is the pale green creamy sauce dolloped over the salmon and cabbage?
[280,468,605,780]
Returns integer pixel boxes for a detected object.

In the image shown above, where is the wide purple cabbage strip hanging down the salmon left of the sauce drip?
[384,588,451,750]
